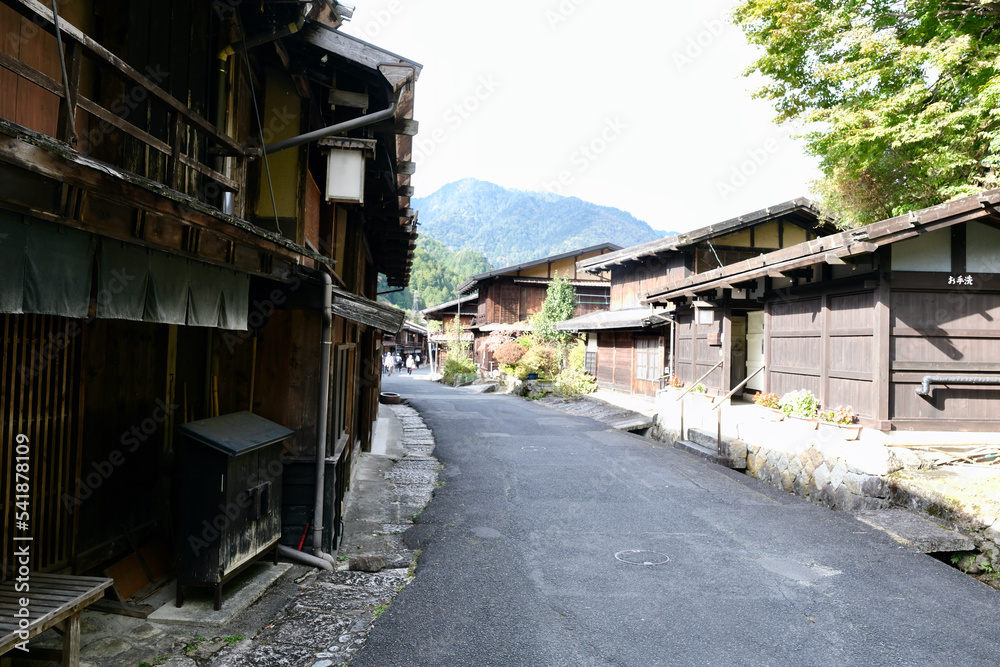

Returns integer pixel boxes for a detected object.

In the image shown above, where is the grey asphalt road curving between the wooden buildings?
[351,373,1000,667]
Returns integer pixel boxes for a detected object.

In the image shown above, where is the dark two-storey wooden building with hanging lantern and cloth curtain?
[0,0,420,592]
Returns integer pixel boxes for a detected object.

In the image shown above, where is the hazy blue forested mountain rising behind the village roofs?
[412,178,663,267]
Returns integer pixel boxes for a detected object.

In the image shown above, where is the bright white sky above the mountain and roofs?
[342,0,819,232]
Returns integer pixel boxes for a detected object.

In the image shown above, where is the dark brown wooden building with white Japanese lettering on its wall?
[644,190,1000,431]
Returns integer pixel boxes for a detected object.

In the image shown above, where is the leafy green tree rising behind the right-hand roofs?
[733,0,1000,224]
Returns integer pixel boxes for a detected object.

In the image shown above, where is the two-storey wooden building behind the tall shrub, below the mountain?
[458,243,621,372]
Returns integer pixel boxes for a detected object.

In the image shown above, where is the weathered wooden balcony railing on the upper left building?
[0,0,250,202]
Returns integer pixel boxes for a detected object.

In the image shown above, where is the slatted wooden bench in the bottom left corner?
[0,572,112,667]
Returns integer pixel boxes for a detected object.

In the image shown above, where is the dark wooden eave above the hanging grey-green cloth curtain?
[0,119,335,277]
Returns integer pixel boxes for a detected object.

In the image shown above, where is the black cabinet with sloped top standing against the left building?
[177,412,293,609]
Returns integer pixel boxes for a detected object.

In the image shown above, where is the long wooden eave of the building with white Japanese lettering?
[642,189,1000,304]
